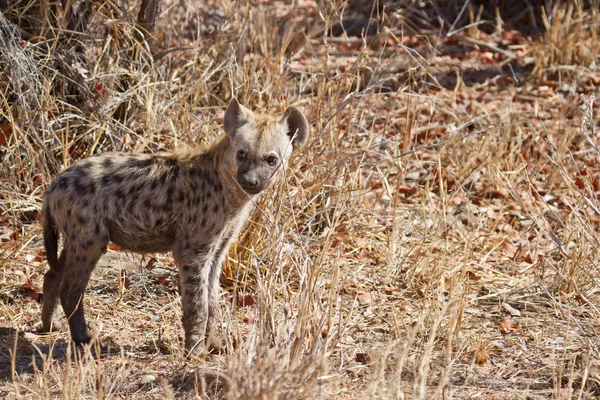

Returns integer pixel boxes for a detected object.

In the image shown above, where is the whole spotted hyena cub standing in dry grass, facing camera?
[42,100,308,354]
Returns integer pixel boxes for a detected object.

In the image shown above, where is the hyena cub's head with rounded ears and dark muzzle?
[224,99,308,195]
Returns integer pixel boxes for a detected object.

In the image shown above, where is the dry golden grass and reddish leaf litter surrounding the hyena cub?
[0,0,600,399]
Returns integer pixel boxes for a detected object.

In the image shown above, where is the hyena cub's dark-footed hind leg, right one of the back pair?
[60,239,108,344]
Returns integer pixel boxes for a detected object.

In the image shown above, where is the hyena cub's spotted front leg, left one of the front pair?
[173,250,212,355]
